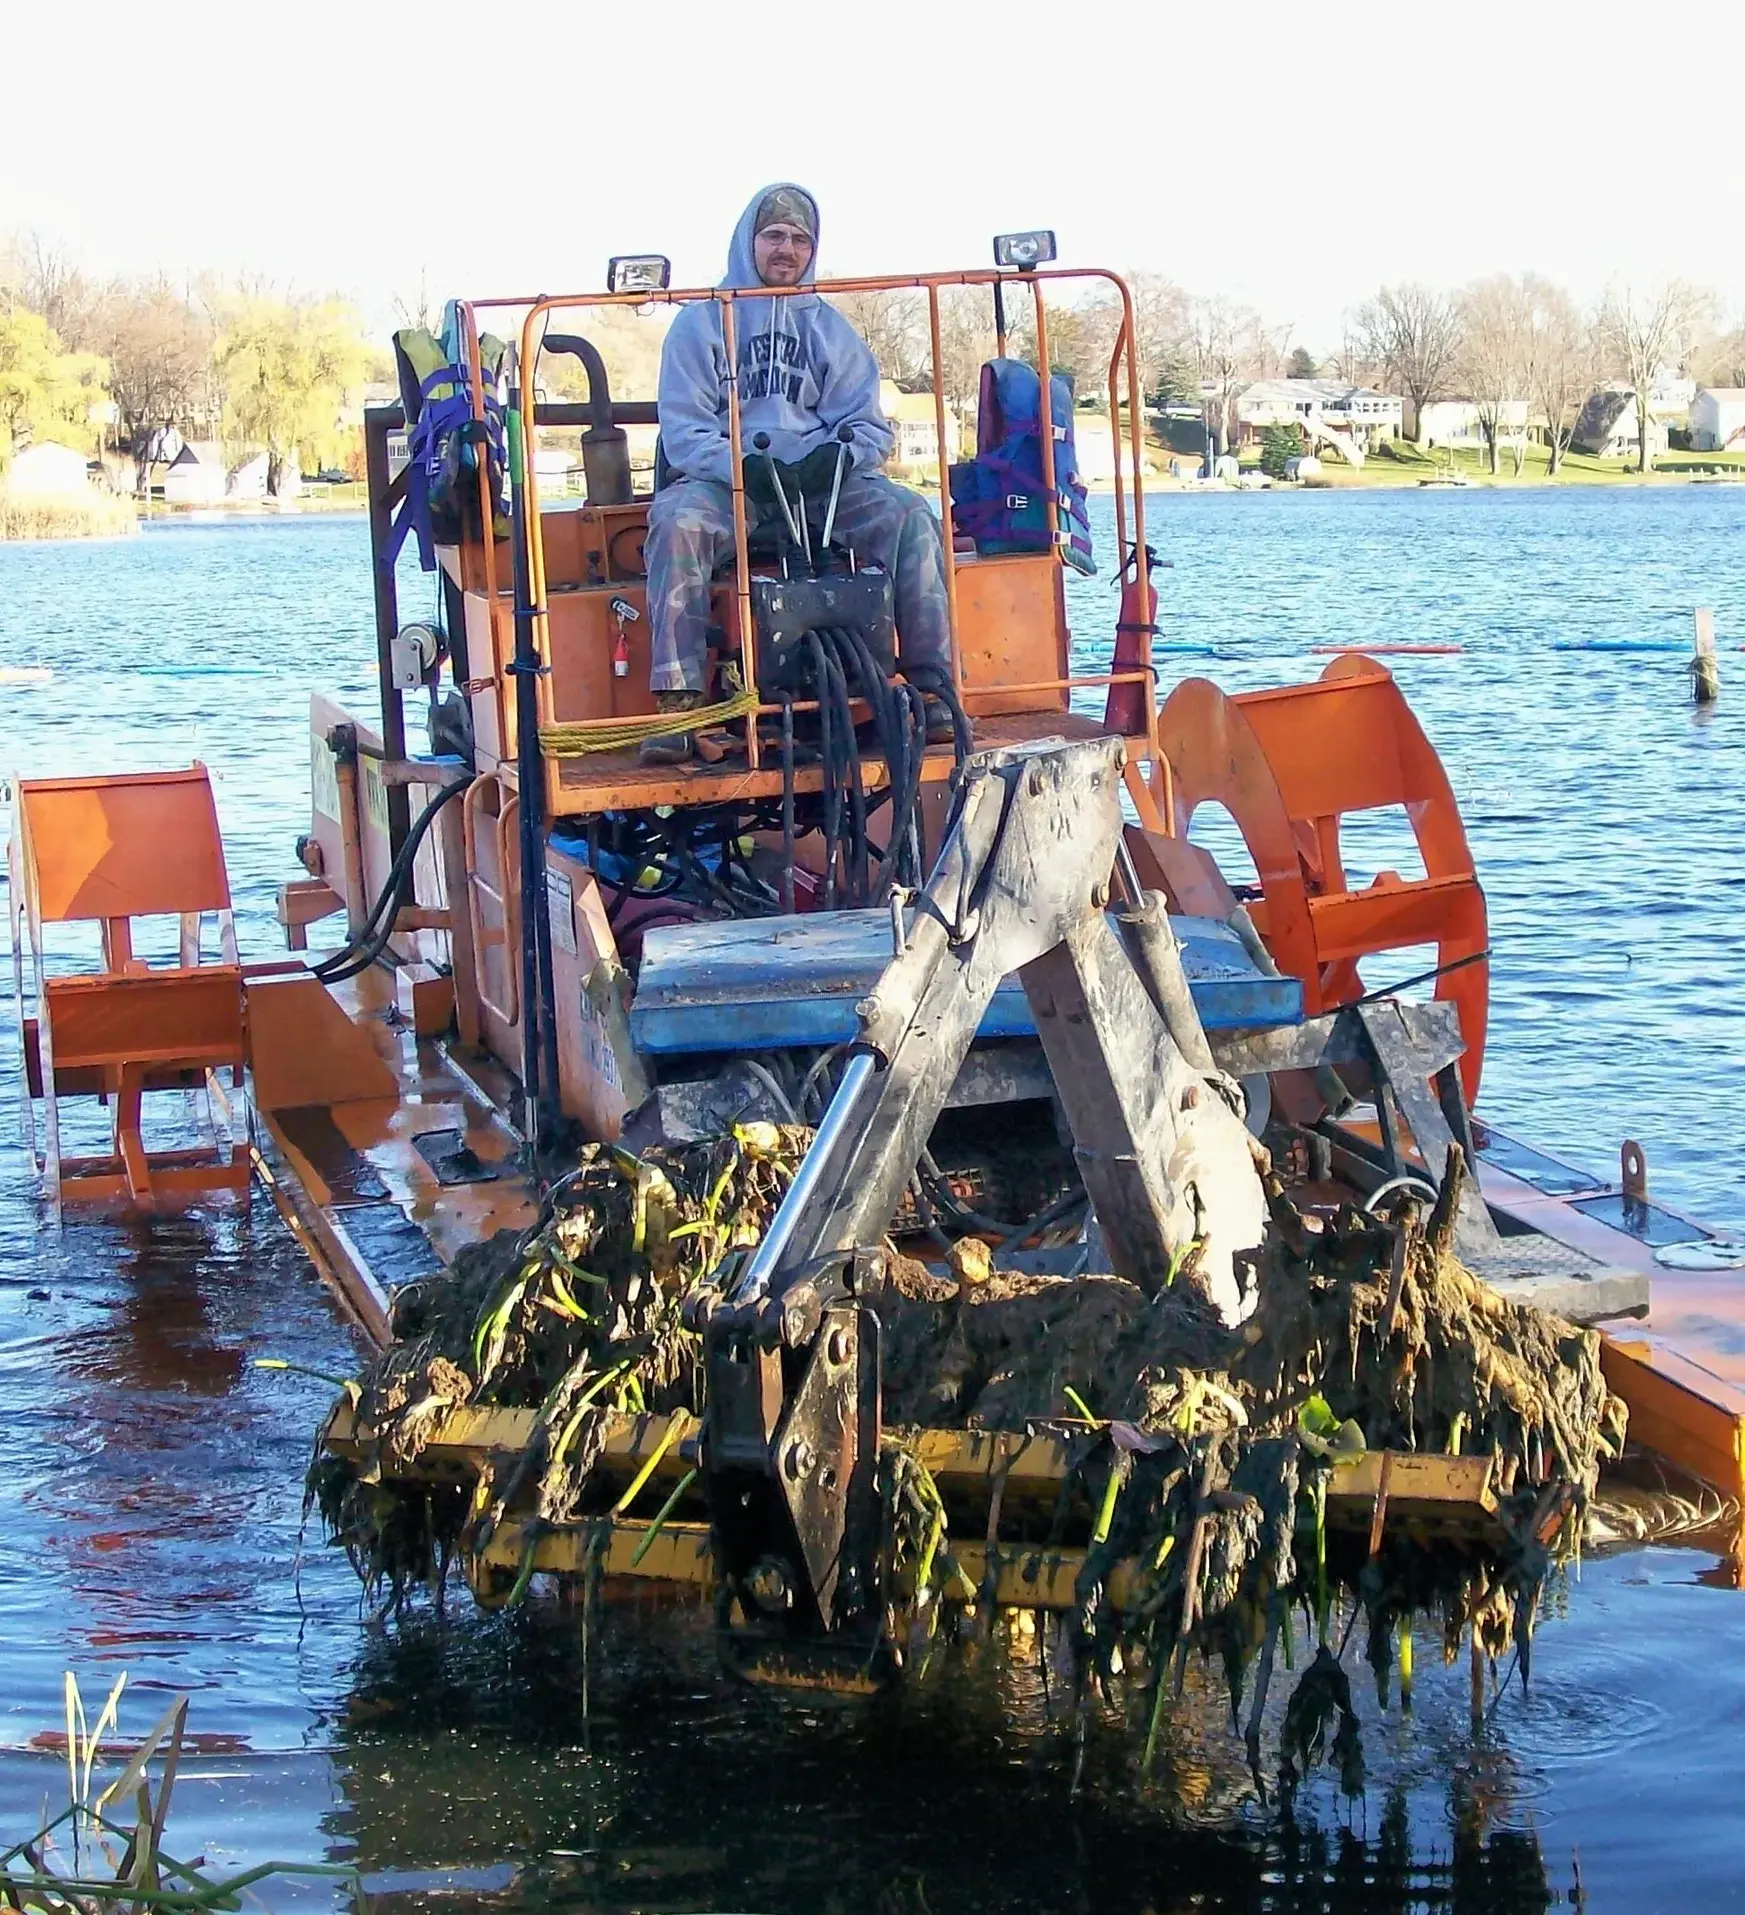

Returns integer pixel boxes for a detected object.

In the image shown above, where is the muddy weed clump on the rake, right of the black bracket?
[881,1155,1624,1791]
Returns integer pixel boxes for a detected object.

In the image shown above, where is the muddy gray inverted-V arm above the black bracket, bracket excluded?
[736,737,1264,1319]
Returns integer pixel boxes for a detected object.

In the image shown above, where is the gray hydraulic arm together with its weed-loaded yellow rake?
[310,737,1622,1769]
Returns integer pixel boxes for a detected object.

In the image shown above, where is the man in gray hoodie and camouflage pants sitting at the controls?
[642,184,952,764]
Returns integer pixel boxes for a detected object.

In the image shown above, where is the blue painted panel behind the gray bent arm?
[630,910,1303,1053]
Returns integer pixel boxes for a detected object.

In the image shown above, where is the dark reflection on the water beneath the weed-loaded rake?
[326,1609,1555,1915]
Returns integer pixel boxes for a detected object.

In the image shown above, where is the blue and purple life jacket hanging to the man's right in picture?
[952,358,1096,573]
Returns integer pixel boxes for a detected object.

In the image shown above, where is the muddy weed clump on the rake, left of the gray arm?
[306,1124,810,1611]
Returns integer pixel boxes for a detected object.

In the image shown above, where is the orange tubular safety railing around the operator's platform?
[444,268,1174,829]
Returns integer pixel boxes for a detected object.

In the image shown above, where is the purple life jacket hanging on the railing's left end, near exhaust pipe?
[383,304,510,573]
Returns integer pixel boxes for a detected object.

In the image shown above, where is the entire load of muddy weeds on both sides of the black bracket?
[310,1124,1624,1791]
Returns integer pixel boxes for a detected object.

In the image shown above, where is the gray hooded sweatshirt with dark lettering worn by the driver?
[661,186,891,484]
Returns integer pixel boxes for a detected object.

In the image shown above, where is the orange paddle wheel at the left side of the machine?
[11,764,249,1206]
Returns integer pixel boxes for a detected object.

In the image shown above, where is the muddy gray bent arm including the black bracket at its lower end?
[703,737,1264,1681]
